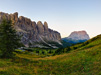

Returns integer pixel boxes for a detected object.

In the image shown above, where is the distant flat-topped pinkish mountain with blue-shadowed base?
[62,31,90,45]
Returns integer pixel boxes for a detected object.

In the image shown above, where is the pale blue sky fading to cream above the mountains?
[0,0,101,37]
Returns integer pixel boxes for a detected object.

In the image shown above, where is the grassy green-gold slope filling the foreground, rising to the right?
[0,35,101,75]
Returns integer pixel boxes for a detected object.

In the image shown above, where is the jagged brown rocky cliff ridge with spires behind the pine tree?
[0,12,61,46]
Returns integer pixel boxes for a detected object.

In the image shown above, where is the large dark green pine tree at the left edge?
[0,19,21,58]
